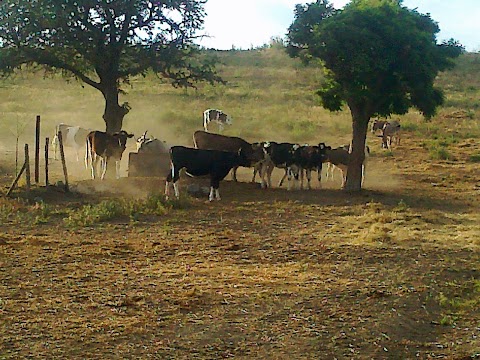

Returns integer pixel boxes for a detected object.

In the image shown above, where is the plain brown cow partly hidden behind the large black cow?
[193,130,264,181]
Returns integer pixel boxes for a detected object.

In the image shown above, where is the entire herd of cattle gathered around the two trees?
[52,109,400,201]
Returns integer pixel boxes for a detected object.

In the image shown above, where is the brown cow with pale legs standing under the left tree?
[85,130,133,180]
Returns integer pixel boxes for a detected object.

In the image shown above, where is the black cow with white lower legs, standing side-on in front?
[165,146,250,201]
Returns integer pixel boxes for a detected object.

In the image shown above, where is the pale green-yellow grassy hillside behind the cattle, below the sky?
[0,48,480,153]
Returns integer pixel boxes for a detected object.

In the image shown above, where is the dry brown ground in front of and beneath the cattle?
[0,134,480,359]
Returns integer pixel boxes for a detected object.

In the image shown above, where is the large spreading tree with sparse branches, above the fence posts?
[0,0,221,133]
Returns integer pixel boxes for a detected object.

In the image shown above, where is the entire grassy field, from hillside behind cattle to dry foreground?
[0,49,480,360]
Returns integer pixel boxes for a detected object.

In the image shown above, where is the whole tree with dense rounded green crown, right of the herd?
[287,0,463,191]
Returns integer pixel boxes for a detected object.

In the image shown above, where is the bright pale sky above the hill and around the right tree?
[200,0,480,52]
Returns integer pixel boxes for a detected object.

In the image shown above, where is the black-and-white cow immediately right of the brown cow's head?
[254,141,300,190]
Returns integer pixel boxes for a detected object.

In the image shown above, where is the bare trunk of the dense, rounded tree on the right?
[345,111,369,191]
